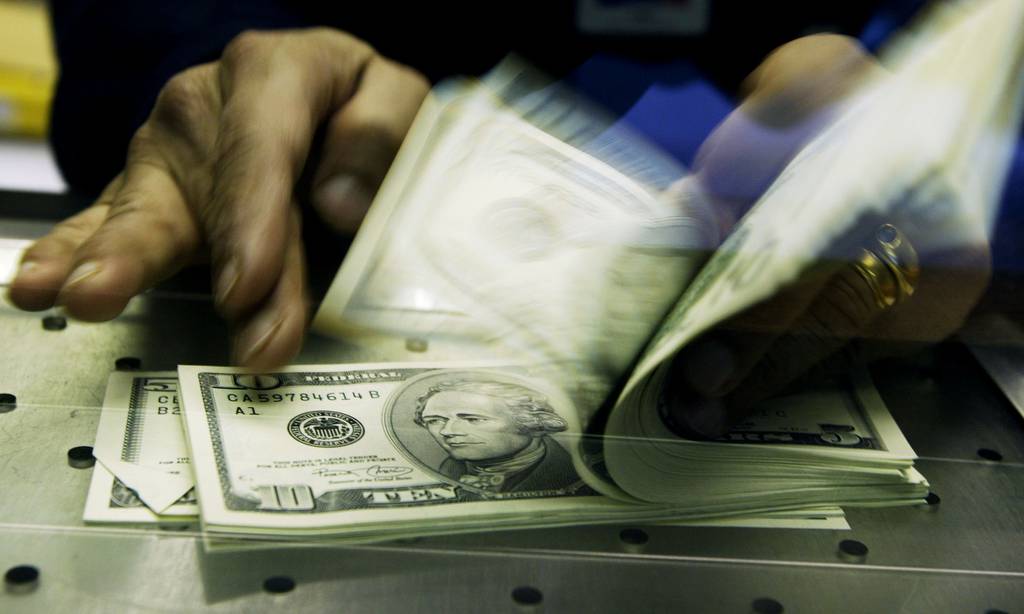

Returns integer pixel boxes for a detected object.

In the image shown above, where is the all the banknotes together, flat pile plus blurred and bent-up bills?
[85,0,1024,540]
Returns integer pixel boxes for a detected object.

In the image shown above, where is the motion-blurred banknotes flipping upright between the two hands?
[313,65,718,427]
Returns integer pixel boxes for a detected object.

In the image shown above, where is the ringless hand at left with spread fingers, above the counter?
[9,29,429,367]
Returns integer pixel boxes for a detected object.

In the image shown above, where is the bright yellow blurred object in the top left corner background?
[0,0,57,137]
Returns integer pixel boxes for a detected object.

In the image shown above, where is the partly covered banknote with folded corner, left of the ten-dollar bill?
[84,371,199,523]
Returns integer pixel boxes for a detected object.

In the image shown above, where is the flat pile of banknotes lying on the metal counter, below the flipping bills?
[85,362,913,540]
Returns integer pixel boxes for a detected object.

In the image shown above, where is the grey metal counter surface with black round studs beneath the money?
[0,208,1024,614]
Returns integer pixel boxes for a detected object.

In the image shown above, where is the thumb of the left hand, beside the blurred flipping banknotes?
[312,57,429,234]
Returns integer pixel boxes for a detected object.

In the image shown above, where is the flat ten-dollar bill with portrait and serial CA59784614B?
[178,363,704,538]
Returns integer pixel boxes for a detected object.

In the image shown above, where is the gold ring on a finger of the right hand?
[853,224,921,309]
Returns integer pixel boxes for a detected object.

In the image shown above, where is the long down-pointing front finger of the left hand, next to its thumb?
[199,30,373,317]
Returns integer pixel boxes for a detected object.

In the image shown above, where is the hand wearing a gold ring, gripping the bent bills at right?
[668,36,991,437]
